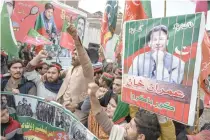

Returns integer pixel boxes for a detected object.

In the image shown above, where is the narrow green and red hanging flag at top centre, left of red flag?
[101,0,118,47]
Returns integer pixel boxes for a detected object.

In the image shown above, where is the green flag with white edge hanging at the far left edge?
[0,3,18,57]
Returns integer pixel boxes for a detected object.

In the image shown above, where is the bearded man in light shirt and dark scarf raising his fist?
[24,50,63,100]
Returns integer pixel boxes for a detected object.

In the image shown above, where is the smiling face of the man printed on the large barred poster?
[149,30,168,52]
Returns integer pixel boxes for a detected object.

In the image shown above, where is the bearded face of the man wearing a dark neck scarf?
[47,67,59,83]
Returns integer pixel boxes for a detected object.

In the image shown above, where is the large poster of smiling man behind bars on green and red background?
[122,13,205,125]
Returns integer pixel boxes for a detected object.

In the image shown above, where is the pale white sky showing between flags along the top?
[79,0,195,18]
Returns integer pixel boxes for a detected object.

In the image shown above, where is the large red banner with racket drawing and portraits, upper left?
[6,1,87,57]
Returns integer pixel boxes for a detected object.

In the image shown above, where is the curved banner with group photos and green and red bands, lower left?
[1,92,97,140]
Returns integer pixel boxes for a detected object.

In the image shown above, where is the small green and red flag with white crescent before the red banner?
[24,29,52,46]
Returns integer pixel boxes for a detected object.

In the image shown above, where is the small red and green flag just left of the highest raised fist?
[60,21,74,51]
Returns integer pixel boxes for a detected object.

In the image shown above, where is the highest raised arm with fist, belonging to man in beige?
[68,21,94,82]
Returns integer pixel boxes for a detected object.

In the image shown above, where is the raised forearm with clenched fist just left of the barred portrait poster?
[88,83,114,134]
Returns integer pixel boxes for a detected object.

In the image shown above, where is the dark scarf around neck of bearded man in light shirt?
[44,80,63,94]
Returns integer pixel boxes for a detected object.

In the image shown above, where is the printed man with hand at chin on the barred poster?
[128,25,185,84]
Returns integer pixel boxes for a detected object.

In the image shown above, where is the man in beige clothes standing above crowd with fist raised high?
[57,21,94,124]
